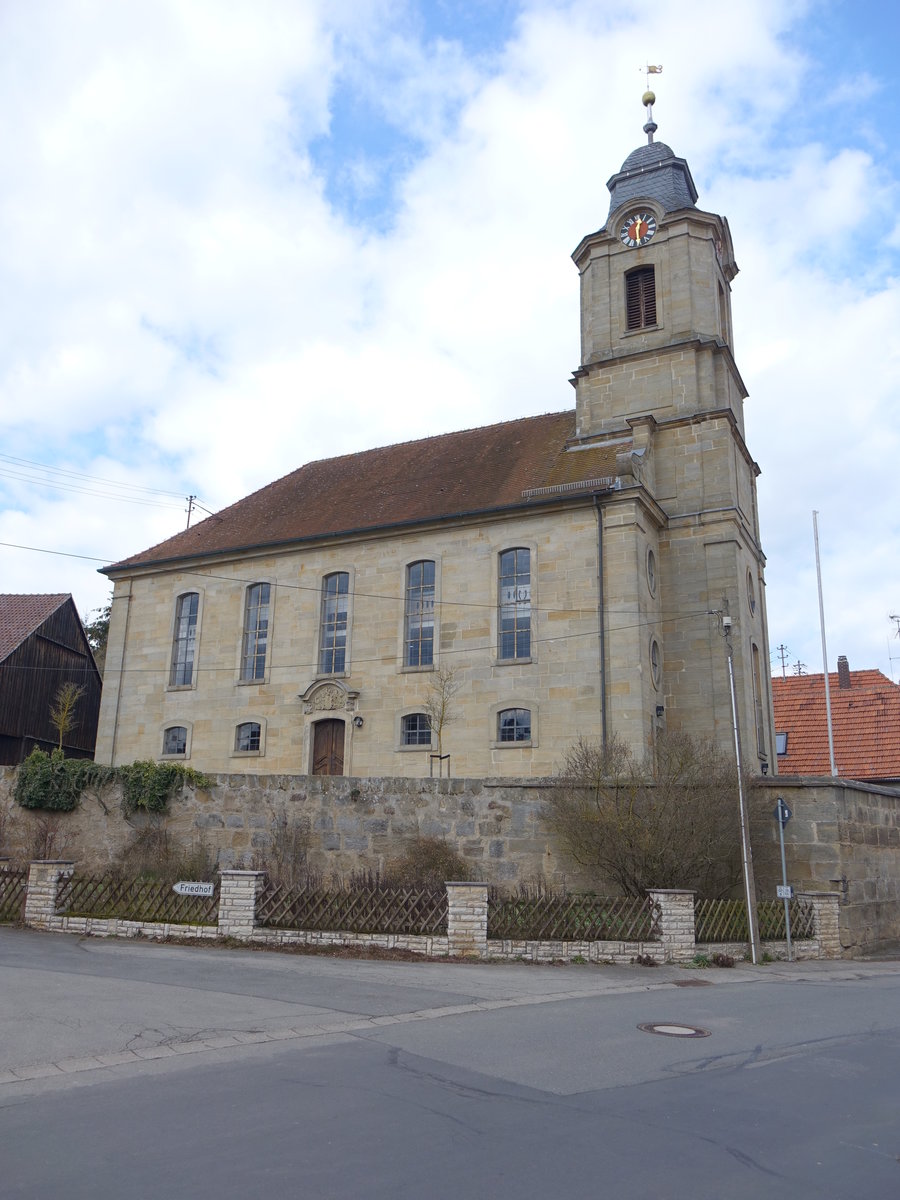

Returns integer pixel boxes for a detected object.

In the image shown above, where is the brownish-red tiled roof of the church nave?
[104,410,622,571]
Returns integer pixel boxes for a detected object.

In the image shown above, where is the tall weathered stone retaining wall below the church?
[0,768,900,955]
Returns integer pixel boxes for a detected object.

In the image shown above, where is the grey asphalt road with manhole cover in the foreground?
[0,928,900,1200]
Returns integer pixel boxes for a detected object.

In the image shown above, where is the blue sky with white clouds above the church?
[0,0,900,678]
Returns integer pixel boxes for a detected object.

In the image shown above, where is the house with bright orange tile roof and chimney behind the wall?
[772,655,900,786]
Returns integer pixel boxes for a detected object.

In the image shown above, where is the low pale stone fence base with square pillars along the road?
[17,860,840,966]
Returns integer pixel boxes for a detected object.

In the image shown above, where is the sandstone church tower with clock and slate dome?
[572,91,776,772]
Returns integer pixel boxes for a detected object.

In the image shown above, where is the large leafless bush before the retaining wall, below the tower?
[541,733,740,896]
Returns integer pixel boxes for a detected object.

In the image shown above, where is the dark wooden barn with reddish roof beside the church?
[0,594,101,766]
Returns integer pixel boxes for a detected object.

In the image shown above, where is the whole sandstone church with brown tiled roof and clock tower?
[97,100,774,776]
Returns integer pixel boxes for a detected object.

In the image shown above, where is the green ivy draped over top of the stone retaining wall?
[16,746,211,814]
